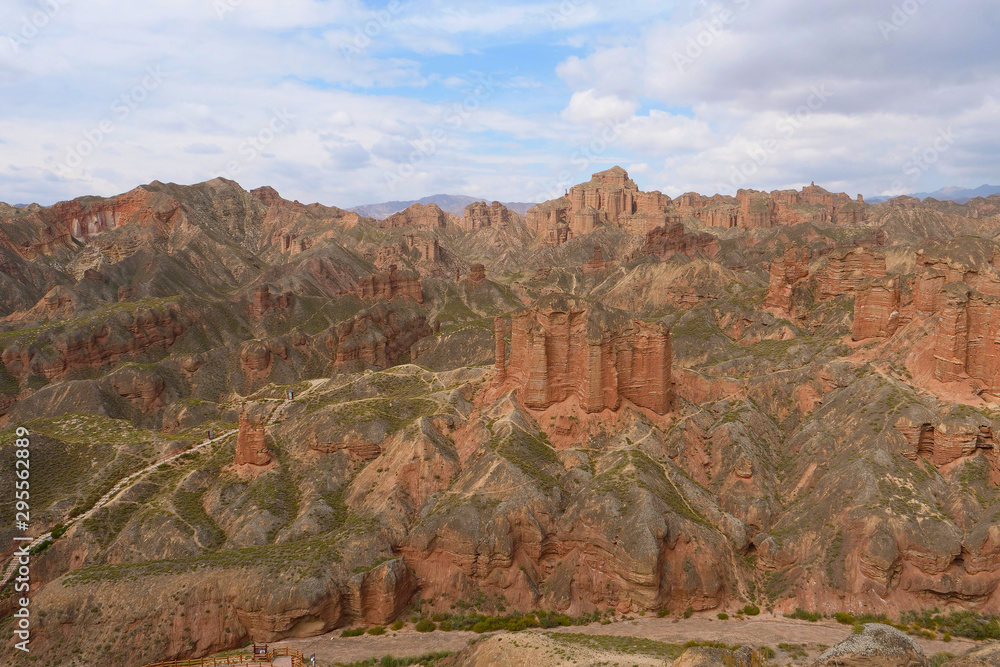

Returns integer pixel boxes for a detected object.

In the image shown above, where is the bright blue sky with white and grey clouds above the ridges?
[0,0,1000,207]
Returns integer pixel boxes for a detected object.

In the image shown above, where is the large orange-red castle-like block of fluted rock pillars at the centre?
[498,294,673,414]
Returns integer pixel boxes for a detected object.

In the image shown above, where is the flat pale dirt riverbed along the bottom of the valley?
[275,616,975,667]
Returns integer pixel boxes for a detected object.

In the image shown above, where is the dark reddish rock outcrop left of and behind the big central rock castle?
[330,302,433,368]
